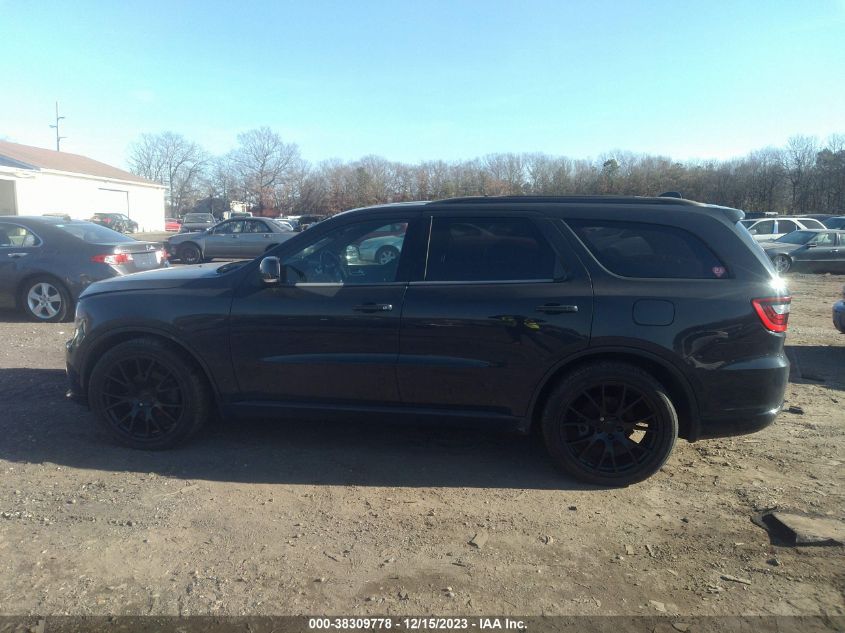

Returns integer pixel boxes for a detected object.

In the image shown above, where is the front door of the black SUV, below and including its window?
[231,217,420,406]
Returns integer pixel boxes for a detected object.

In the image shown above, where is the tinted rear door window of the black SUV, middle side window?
[425,218,562,281]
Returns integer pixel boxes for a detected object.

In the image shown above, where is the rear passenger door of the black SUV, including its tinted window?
[397,211,593,417]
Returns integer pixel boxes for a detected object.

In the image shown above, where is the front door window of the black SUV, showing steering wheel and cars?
[283,220,408,285]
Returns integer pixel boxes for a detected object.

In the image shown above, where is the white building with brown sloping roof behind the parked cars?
[0,141,165,231]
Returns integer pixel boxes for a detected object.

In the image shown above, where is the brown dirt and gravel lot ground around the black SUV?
[0,276,845,615]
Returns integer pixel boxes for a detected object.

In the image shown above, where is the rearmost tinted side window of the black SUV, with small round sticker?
[567,220,728,279]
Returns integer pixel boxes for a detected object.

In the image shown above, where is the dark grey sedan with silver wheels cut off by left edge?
[0,216,167,321]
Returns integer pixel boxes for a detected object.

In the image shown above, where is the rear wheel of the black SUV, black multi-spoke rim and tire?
[542,362,678,486]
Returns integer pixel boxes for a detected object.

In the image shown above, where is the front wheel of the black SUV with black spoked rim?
[88,338,212,450]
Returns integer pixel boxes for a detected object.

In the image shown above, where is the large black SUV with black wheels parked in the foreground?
[67,197,790,485]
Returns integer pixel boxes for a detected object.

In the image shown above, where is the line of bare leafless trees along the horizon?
[129,127,845,216]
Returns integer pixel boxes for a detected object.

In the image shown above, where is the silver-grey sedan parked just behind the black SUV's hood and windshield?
[166,218,296,264]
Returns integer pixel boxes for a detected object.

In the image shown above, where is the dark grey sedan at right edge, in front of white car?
[760,229,845,274]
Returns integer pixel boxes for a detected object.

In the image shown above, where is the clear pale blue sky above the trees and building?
[0,0,845,165]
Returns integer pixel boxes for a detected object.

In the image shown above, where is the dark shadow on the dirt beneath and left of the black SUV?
[0,369,591,490]
